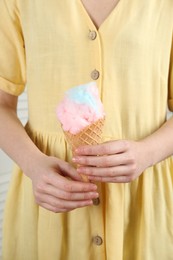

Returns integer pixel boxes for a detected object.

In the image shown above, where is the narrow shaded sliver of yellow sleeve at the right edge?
[168,34,173,112]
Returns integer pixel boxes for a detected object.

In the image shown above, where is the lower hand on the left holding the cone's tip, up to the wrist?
[26,155,98,213]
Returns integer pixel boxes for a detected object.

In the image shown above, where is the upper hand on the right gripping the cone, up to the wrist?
[73,140,150,183]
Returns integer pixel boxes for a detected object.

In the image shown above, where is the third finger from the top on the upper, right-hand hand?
[77,165,134,178]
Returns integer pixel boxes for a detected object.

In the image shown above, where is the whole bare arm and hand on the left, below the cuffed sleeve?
[0,90,98,212]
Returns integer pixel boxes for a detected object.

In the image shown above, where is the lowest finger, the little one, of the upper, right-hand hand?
[88,175,134,183]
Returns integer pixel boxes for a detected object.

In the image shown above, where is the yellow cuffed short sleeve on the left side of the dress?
[0,0,25,96]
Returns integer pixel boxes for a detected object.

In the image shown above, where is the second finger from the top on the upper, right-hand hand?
[73,153,133,167]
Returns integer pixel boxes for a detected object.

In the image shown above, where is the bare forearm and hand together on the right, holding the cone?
[73,121,173,183]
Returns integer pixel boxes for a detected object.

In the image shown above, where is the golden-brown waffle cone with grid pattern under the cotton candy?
[64,118,105,182]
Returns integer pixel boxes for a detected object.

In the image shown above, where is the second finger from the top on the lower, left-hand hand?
[45,185,99,201]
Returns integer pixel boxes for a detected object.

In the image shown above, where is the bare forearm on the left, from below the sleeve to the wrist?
[0,105,41,176]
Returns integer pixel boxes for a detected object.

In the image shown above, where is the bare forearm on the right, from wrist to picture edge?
[141,117,173,166]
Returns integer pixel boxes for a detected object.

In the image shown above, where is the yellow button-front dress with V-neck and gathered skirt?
[0,0,173,260]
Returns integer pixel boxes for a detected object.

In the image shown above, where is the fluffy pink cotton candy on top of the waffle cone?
[57,83,105,134]
